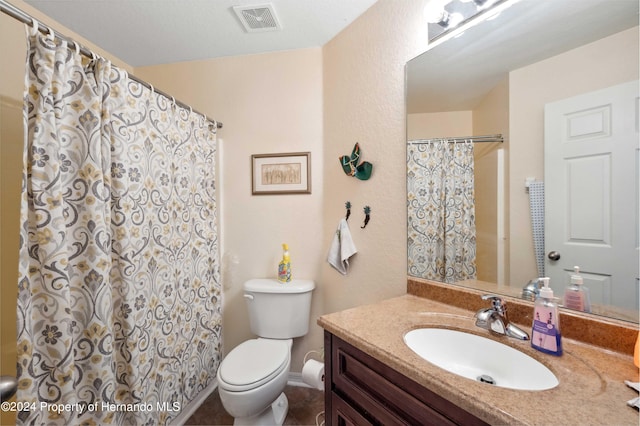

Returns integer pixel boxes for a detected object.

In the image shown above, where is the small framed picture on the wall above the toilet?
[251,152,311,195]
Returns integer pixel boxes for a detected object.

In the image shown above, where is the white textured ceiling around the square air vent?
[25,0,377,67]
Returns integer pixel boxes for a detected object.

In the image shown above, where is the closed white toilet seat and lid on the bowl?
[218,339,290,392]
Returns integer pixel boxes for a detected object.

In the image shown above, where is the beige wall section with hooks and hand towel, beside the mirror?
[320,0,427,321]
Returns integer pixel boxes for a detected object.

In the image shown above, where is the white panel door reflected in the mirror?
[545,81,640,309]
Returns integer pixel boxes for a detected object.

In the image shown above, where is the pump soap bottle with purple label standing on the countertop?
[531,277,562,356]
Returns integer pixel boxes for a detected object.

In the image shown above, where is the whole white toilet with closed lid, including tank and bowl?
[218,278,315,425]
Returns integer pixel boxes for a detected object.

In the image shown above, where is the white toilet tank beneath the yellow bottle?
[244,278,315,339]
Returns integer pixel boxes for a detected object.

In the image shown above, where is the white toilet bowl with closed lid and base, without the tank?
[217,338,292,425]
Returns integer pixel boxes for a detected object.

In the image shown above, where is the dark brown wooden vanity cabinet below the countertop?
[324,331,486,426]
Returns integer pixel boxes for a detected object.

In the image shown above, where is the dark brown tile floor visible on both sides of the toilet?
[185,386,324,426]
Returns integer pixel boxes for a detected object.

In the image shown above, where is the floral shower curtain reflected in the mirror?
[407,139,476,283]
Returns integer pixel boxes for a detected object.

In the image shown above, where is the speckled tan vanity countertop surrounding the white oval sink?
[318,294,639,425]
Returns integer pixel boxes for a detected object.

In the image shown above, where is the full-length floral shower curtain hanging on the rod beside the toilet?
[18,31,221,425]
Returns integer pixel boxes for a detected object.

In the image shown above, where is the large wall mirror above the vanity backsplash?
[406,0,640,322]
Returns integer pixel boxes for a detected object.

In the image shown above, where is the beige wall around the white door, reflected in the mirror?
[509,27,639,287]
